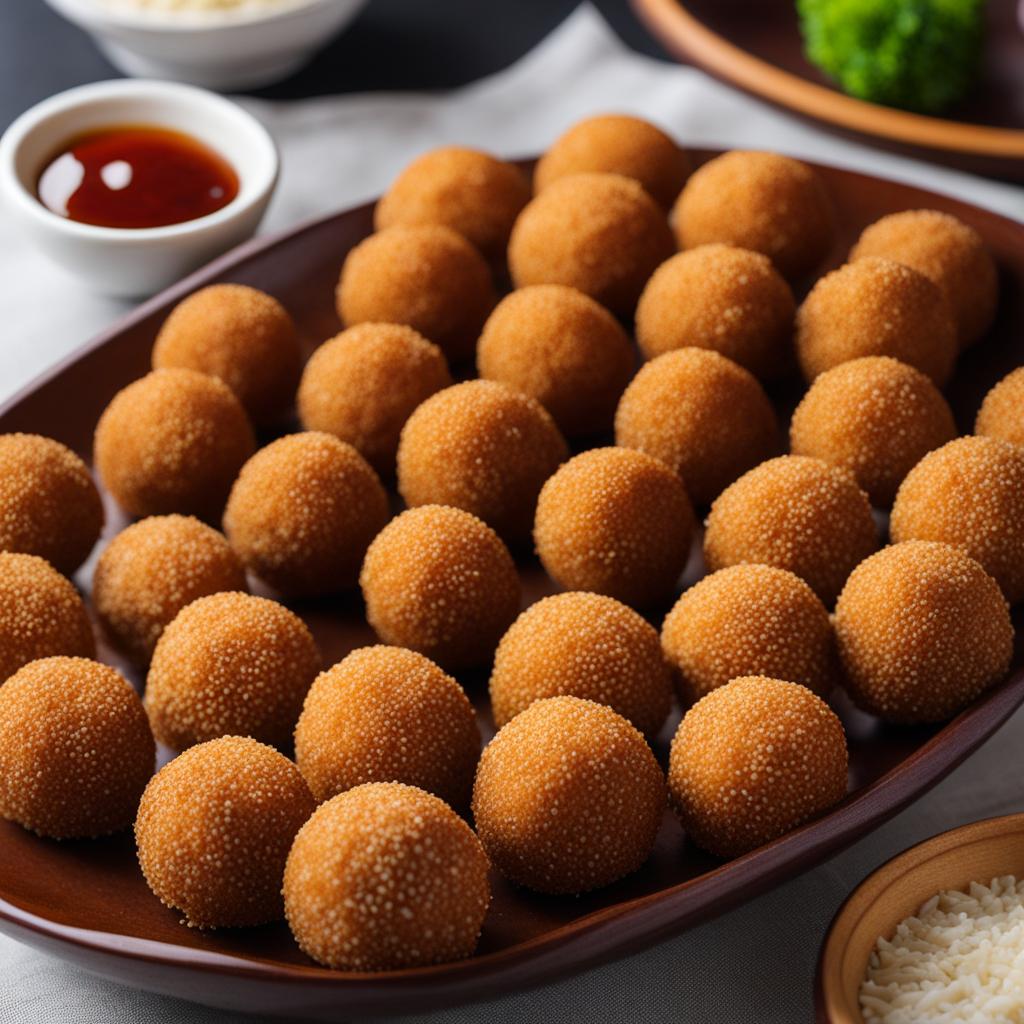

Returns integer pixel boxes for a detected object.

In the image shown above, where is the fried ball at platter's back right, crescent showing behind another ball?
[850,210,999,348]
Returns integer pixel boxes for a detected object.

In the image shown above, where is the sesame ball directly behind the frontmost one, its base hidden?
[295,645,480,809]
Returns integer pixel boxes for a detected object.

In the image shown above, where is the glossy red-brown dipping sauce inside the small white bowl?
[36,125,239,228]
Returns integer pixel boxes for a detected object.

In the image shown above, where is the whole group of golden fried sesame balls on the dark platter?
[0,116,1024,971]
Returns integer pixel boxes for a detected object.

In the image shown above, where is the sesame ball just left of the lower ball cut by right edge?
[705,455,879,608]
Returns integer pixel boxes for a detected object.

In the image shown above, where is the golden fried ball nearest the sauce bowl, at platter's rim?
[153,285,302,424]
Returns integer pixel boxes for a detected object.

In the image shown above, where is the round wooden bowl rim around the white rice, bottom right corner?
[814,814,1024,1024]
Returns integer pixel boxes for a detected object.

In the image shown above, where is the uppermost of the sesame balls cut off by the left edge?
[0,434,103,575]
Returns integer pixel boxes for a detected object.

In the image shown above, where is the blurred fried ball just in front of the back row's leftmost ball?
[336,224,497,361]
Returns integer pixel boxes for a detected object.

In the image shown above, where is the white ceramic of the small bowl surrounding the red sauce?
[0,79,278,297]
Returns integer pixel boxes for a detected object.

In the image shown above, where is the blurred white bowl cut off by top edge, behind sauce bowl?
[46,0,367,90]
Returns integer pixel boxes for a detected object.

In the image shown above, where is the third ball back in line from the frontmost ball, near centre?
[359,505,519,669]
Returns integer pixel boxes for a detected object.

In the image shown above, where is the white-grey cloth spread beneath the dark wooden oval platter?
[0,4,1024,1024]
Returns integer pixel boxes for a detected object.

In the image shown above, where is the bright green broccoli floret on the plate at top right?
[797,0,984,114]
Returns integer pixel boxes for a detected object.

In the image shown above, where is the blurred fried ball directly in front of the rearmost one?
[509,174,675,316]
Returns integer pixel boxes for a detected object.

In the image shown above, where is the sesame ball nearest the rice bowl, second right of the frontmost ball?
[669,676,848,857]
